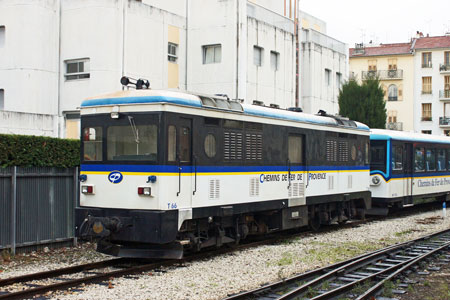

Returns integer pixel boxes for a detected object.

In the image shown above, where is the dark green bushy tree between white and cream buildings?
[338,78,387,129]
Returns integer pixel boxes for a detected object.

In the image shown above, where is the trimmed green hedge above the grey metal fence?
[0,134,80,168]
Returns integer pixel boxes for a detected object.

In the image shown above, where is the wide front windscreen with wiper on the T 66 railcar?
[107,121,158,161]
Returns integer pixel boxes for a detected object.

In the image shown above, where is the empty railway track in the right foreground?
[226,230,450,300]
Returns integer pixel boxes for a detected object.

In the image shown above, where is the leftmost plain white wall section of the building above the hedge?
[0,0,59,114]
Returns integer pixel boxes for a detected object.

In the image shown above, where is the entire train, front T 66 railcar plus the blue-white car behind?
[75,78,450,259]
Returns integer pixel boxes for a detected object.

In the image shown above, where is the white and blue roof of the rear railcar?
[370,129,450,144]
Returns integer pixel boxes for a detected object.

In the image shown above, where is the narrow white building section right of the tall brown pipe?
[299,12,348,114]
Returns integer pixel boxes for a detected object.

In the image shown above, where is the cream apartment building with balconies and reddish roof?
[350,33,450,135]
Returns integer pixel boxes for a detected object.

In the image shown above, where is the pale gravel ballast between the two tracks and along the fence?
[0,210,450,299]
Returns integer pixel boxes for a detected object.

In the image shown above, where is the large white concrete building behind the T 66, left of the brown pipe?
[0,0,346,138]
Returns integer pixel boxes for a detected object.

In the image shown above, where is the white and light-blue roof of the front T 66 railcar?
[81,89,370,131]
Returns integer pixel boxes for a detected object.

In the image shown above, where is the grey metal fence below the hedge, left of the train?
[0,167,78,254]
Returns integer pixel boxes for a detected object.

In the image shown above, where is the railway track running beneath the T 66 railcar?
[0,204,442,300]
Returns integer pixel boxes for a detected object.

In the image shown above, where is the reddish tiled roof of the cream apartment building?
[349,36,450,58]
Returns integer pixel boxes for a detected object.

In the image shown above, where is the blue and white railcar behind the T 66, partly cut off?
[370,129,450,208]
